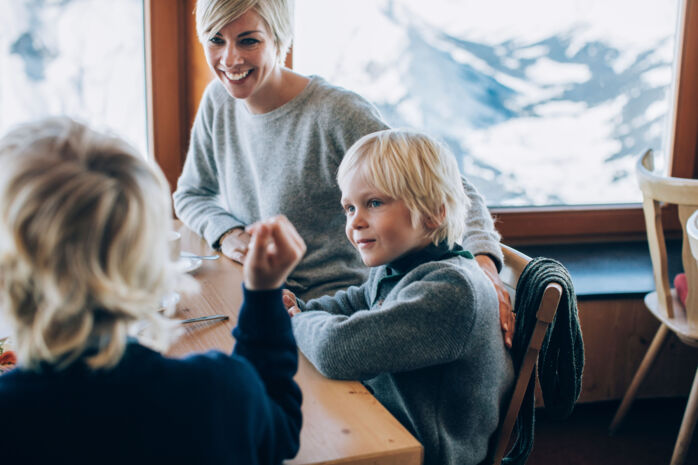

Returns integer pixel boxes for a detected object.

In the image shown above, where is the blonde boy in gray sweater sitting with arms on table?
[284,130,513,465]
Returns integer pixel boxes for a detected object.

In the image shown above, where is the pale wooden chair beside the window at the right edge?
[609,150,698,465]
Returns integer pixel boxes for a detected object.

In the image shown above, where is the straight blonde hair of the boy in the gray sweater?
[337,129,470,247]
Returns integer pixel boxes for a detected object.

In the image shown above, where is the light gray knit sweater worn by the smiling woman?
[174,77,501,298]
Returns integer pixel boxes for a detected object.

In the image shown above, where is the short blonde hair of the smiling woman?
[196,0,293,65]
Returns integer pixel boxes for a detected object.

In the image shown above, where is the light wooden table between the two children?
[169,226,423,465]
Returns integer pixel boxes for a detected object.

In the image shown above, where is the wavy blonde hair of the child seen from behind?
[0,118,175,368]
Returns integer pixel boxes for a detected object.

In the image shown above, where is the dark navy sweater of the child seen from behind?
[0,290,301,465]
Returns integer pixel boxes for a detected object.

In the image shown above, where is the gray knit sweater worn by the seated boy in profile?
[291,245,514,465]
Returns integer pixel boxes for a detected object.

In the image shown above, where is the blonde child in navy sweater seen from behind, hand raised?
[0,118,305,465]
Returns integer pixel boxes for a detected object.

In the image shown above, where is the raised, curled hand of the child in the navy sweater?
[243,215,306,290]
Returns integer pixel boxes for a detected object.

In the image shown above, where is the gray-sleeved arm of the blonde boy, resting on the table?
[291,269,479,379]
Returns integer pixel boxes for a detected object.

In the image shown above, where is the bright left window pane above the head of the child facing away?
[0,0,147,154]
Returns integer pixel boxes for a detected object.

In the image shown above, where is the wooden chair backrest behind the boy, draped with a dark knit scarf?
[488,245,562,465]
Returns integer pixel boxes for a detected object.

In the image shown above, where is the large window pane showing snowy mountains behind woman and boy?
[294,0,678,206]
